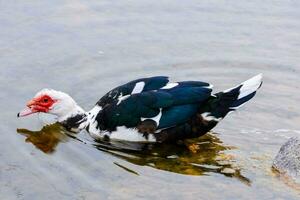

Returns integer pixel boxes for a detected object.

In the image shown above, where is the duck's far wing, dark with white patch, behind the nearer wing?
[97,76,169,107]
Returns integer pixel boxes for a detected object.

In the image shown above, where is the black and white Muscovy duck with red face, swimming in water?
[17,74,263,143]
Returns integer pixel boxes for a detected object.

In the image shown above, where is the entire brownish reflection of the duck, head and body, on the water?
[17,123,250,184]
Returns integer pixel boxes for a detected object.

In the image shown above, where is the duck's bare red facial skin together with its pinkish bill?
[18,94,57,117]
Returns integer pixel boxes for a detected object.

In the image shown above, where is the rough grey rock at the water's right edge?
[273,137,300,182]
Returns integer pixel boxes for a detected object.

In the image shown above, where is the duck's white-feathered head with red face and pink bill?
[18,89,84,121]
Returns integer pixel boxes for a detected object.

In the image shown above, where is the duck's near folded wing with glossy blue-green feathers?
[96,85,212,131]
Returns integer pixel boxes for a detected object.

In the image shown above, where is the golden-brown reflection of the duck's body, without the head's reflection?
[94,133,250,184]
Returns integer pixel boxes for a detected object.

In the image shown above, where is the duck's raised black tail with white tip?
[201,74,262,122]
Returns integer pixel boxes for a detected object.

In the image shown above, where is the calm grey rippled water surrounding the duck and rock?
[0,0,300,199]
